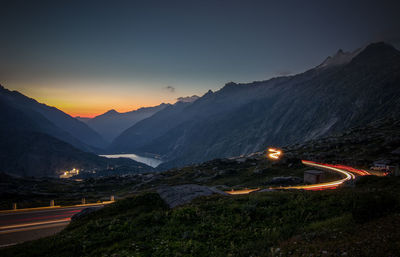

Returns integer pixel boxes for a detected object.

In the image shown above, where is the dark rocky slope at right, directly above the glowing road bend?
[284,118,400,169]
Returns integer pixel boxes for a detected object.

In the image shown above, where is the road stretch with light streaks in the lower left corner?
[0,203,108,247]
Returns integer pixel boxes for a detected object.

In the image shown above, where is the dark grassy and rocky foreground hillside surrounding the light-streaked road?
[0,119,400,254]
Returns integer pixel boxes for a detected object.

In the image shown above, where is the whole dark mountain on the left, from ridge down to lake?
[0,87,152,177]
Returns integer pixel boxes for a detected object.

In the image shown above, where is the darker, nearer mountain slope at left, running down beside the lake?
[0,101,152,177]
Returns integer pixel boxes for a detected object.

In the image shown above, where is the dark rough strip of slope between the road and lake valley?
[0,157,337,209]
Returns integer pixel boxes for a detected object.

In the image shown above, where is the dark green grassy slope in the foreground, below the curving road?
[0,178,400,256]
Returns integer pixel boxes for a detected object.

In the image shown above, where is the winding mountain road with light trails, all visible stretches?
[0,160,370,247]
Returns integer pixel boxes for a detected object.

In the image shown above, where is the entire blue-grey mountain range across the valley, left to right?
[0,42,400,176]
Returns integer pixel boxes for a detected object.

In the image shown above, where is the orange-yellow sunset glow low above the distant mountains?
[10,82,186,118]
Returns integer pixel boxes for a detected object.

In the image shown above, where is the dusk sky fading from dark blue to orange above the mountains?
[0,0,400,117]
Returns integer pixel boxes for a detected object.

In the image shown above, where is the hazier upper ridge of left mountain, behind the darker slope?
[0,86,107,151]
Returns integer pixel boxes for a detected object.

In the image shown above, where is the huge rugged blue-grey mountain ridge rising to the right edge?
[110,42,400,168]
